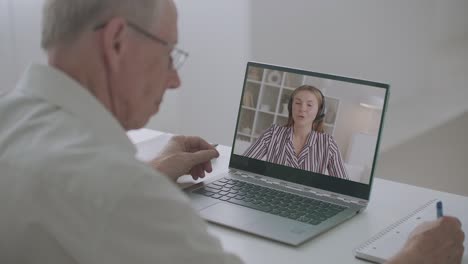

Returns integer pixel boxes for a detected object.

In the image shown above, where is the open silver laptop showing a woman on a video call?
[186,62,389,246]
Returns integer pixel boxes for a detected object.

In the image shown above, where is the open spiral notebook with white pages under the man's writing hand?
[355,199,468,264]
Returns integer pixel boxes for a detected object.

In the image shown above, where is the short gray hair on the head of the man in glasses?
[41,0,164,50]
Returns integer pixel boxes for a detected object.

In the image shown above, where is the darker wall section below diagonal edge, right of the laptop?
[377,112,468,196]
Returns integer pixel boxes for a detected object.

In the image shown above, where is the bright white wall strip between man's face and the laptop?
[149,0,251,145]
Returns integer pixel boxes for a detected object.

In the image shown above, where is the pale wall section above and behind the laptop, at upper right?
[252,0,468,149]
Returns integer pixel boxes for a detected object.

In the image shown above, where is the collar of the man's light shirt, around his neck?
[17,64,136,153]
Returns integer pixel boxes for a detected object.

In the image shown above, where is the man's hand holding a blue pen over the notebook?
[388,216,465,264]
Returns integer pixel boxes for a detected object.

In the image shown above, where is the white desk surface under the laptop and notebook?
[129,130,468,264]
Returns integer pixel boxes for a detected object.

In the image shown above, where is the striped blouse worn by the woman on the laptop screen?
[244,125,349,179]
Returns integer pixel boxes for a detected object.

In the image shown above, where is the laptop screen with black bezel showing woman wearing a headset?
[230,62,389,199]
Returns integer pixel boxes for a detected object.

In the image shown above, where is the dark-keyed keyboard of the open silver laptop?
[194,178,346,225]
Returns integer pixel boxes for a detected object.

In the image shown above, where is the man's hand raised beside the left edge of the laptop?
[151,136,219,181]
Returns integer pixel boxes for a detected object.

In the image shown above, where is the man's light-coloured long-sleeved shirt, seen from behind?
[0,65,240,264]
